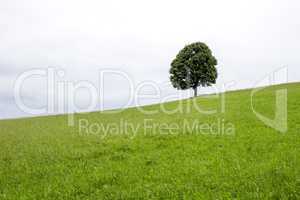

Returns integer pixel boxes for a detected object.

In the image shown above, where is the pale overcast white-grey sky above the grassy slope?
[0,0,300,119]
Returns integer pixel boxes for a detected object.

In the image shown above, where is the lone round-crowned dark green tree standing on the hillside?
[170,42,218,97]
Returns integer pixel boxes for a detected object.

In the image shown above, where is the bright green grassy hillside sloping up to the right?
[0,83,300,199]
